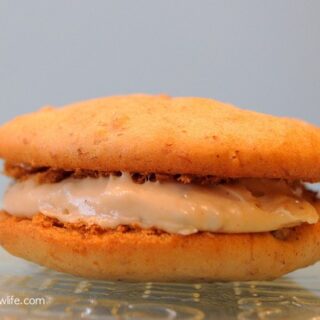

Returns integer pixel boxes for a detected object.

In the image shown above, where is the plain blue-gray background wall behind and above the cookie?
[0,0,320,191]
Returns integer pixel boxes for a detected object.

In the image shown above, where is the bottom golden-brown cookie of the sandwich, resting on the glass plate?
[0,213,320,281]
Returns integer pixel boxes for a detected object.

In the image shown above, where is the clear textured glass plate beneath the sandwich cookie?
[0,250,320,320]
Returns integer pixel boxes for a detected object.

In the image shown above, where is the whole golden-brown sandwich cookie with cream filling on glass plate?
[0,95,320,281]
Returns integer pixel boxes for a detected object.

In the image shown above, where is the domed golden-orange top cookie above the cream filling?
[0,95,320,182]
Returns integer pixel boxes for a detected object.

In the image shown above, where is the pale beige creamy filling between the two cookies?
[4,173,319,235]
